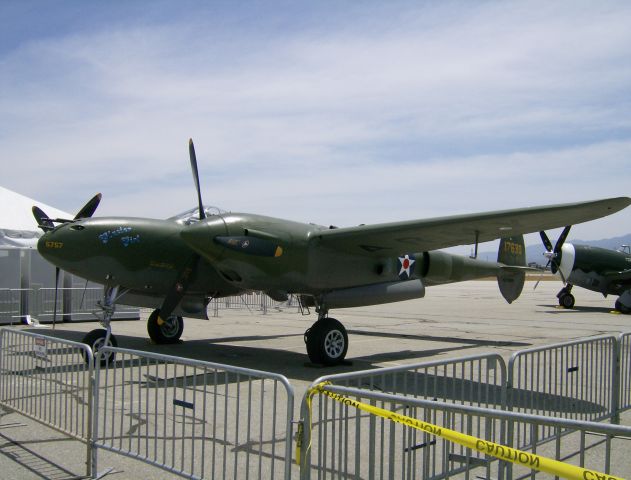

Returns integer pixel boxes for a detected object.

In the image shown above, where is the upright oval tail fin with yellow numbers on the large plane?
[497,235,527,303]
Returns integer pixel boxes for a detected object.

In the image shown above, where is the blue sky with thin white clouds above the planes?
[0,1,631,251]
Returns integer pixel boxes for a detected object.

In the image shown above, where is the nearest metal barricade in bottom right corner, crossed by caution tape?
[301,385,631,480]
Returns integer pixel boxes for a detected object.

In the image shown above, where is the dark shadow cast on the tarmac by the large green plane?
[23,330,606,414]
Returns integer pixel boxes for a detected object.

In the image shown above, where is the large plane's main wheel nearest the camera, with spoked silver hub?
[305,318,348,365]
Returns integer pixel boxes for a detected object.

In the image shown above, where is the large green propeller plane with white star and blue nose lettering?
[33,141,631,365]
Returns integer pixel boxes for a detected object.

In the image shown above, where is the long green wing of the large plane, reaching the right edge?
[311,197,631,255]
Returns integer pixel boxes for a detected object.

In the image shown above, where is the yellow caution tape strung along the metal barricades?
[296,382,624,480]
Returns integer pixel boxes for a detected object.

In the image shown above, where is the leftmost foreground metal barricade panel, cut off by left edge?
[0,328,94,474]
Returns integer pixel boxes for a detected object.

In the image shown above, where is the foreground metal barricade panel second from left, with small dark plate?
[93,348,294,479]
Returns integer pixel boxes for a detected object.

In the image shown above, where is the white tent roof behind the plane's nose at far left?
[0,187,74,248]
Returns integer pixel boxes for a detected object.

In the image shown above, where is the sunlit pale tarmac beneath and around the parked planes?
[0,281,631,479]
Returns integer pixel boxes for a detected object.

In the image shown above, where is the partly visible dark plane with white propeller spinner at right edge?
[539,226,631,314]
